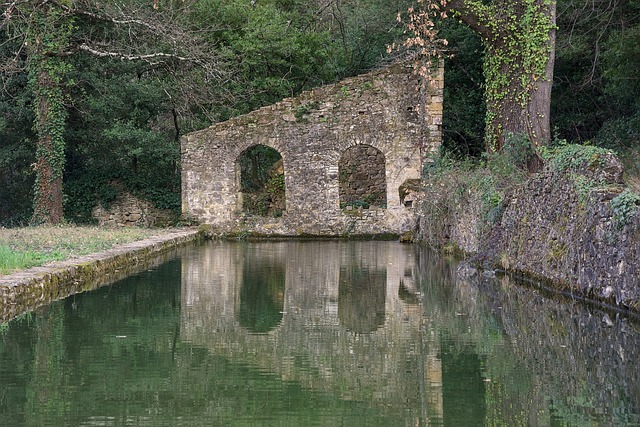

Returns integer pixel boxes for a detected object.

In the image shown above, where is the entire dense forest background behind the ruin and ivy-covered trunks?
[0,0,640,226]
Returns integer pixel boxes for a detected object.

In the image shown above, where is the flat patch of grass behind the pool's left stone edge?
[0,226,171,275]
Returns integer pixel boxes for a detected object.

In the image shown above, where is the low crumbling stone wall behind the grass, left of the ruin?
[91,191,176,227]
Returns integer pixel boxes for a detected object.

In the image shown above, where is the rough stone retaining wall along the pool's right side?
[421,155,640,311]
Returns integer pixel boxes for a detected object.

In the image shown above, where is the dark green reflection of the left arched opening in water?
[237,259,286,333]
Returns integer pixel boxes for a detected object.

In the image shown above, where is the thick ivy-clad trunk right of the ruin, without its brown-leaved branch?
[470,0,555,152]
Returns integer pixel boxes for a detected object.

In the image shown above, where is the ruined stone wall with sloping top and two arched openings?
[182,64,444,235]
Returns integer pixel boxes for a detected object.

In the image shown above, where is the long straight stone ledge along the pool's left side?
[0,229,202,322]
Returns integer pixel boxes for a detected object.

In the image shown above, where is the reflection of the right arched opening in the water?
[338,264,387,334]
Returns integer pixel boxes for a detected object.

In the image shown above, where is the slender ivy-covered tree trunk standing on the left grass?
[27,5,72,224]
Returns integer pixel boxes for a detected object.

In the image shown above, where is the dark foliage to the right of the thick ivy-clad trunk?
[551,0,640,149]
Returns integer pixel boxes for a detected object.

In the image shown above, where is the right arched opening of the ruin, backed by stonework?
[338,145,387,209]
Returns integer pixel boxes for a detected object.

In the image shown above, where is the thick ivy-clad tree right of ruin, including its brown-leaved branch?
[405,0,556,157]
